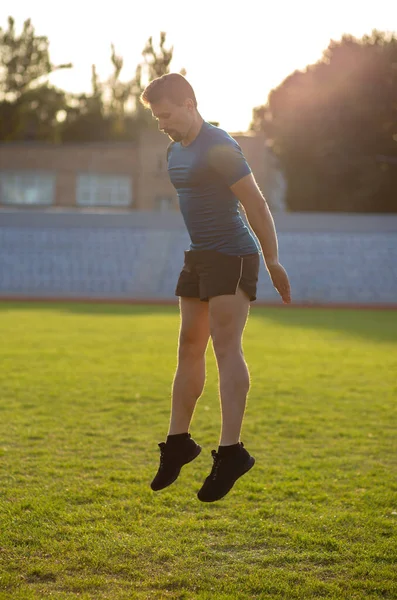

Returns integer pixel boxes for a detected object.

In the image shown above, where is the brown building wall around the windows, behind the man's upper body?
[0,130,284,212]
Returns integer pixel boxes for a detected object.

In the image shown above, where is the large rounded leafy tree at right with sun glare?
[252,31,397,212]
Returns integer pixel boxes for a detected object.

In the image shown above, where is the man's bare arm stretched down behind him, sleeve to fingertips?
[230,173,291,304]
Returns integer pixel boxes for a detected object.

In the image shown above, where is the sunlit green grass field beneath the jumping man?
[0,303,397,600]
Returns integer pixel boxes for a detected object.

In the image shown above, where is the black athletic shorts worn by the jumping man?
[175,250,259,302]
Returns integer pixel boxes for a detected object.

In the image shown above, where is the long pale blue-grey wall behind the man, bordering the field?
[0,209,397,305]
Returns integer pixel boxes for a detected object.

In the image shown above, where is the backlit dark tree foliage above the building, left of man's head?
[0,17,173,142]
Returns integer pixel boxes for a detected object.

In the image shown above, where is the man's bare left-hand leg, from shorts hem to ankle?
[168,298,210,435]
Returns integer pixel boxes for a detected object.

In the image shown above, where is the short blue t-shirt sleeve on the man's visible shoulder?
[208,140,251,186]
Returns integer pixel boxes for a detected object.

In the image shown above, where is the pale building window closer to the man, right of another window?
[76,174,132,206]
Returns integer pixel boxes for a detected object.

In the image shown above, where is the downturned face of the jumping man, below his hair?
[150,98,193,142]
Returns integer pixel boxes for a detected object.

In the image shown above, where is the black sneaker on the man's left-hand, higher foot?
[150,433,201,492]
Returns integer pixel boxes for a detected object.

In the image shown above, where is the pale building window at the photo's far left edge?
[0,171,55,206]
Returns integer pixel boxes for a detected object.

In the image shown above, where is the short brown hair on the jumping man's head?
[140,73,197,108]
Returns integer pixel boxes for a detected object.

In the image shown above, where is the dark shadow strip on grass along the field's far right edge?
[251,307,397,342]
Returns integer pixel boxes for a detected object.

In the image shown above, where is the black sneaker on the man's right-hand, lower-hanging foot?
[197,443,255,502]
